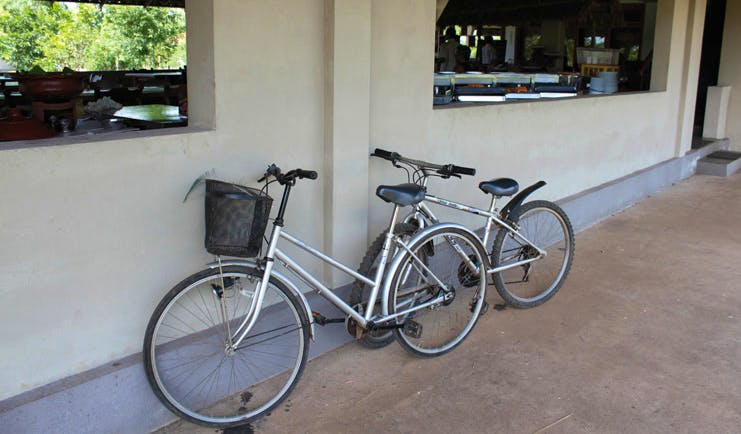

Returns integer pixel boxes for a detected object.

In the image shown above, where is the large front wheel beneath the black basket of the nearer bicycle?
[144,266,309,428]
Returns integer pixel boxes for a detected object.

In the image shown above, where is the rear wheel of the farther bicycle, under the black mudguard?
[491,200,575,309]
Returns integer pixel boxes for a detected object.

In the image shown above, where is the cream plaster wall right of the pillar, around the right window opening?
[370,0,704,233]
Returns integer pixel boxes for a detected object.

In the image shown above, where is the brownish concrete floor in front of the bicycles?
[158,174,741,434]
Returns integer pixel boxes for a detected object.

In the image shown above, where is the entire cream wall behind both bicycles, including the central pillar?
[0,0,704,399]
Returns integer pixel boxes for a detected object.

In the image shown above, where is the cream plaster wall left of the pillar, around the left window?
[0,0,324,400]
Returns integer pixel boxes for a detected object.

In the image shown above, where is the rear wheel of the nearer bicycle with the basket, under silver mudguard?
[388,225,488,357]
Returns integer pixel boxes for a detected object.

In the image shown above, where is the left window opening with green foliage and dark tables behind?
[0,0,188,141]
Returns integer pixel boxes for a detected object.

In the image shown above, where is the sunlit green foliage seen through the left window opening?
[0,0,185,71]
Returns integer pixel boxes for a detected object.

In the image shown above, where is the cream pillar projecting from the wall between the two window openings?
[323,0,371,286]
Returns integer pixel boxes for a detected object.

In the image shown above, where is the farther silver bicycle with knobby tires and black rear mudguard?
[350,149,574,348]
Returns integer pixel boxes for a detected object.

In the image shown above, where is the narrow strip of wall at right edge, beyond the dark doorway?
[718,1,741,150]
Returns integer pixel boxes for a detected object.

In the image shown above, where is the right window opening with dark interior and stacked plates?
[433,0,656,105]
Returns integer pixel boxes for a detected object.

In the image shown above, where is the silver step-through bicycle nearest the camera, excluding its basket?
[144,165,489,428]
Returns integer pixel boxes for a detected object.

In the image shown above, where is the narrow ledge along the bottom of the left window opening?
[0,127,213,152]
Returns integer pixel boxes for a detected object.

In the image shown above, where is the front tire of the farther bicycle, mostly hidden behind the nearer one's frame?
[350,223,417,349]
